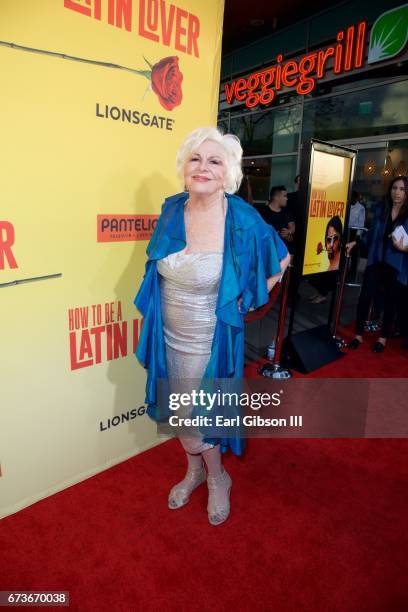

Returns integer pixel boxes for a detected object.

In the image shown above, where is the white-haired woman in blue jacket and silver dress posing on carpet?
[135,128,289,525]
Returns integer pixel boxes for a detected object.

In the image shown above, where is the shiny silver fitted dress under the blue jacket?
[157,252,223,453]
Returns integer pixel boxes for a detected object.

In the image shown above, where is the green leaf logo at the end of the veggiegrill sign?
[367,4,408,64]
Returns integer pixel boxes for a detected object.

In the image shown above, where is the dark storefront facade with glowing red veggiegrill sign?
[219,0,408,212]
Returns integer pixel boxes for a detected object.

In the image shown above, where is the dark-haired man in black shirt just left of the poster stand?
[256,185,295,254]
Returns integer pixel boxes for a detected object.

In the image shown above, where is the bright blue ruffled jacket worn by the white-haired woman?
[134,193,288,455]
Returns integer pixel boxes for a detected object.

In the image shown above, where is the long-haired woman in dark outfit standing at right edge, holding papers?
[347,176,408,353]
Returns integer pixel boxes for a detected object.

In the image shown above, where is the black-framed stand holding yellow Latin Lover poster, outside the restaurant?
[284,139,357,373]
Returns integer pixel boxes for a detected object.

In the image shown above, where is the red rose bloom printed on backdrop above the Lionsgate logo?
[152,57,183,110]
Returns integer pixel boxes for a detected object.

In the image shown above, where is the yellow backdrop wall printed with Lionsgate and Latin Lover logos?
[0,0,224,516]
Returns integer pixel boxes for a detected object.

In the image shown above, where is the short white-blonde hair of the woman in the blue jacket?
[176,127,242,193]
